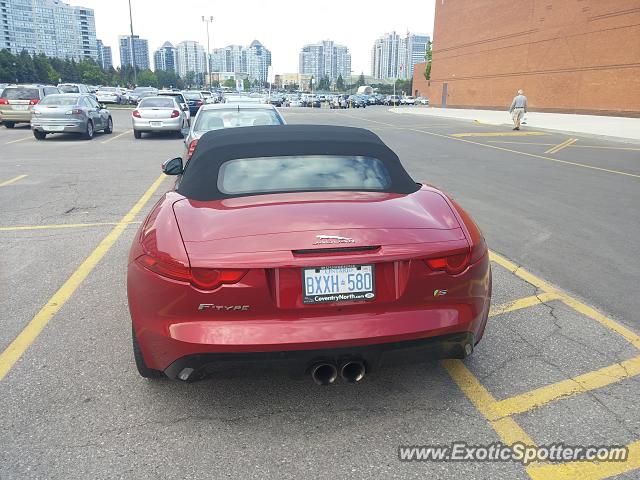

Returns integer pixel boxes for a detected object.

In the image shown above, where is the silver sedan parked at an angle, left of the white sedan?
[31,93,113,140]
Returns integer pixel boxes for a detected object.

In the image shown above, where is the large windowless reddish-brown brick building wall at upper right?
[413,0,640,116]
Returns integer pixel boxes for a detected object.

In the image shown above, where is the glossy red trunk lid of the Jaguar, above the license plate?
[174,189,468,268]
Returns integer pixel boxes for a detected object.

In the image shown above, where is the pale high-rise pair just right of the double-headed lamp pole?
[211,40,271,83]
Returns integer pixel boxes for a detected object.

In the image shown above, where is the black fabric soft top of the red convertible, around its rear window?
[177,125,419,201]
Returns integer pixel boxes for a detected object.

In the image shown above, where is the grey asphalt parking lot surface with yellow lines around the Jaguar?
[0,107,640,480]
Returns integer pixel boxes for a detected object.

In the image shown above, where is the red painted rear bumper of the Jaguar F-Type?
[128,256,491,371]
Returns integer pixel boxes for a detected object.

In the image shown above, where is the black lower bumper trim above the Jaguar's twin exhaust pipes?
[163,332,476,381]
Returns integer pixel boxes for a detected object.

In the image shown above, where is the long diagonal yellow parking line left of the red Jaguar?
[0,174,166,380]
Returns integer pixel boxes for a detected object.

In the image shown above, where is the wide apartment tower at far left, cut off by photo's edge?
[0,0,98,60]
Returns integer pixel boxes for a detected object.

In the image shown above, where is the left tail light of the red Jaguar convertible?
[136,253,248,290]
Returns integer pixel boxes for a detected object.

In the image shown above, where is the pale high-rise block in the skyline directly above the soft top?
[298,40,351,82]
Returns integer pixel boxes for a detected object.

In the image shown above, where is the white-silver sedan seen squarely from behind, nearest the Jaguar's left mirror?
[131,96,189,138]
